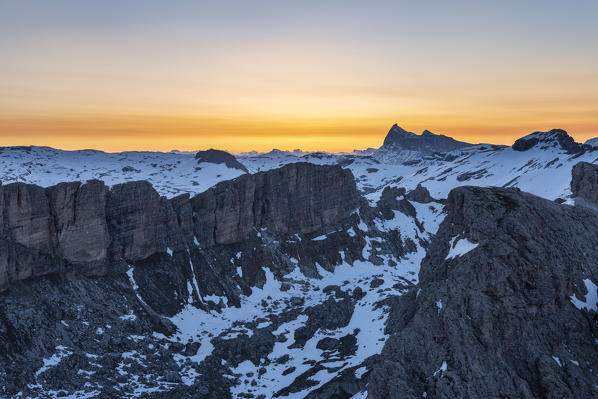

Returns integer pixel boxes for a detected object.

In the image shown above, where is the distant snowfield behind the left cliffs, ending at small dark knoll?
[0,147,245,197]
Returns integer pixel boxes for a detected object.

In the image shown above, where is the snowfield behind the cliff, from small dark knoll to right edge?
[240,132,598,200]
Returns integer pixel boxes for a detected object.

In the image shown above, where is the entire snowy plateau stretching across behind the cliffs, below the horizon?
[0,129,598,200]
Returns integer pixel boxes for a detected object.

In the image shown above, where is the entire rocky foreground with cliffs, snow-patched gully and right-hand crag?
[0,163,598,398]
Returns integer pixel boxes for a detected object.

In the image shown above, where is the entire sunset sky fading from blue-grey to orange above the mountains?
[0,0,598,152]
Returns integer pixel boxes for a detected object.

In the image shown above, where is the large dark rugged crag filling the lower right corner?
[368,187,598,398]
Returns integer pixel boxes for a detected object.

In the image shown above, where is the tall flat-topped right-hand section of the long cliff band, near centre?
[192,163,360,245]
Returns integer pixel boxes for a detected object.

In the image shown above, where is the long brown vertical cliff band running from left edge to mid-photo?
[0,163,360,290]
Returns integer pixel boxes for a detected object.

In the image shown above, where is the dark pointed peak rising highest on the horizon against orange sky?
[380,124,473,155]
